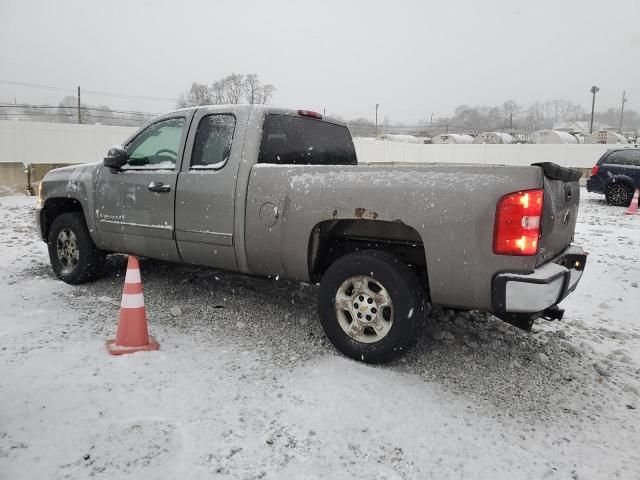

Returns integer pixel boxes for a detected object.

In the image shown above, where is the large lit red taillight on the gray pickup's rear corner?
[493,189,544,255]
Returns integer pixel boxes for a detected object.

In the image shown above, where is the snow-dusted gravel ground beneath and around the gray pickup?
[0,191,640,480]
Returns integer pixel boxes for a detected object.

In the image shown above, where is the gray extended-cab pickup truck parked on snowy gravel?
[36,105,586,362]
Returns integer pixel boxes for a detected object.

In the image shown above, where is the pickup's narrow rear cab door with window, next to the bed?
[175,107,246,270]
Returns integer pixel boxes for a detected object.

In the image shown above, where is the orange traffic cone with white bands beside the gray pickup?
[107,255,160,355]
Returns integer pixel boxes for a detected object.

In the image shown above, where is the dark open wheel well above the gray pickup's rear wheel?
[307,220,428,291]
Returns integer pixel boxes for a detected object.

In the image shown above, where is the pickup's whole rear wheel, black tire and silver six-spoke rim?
[318,250,426,363]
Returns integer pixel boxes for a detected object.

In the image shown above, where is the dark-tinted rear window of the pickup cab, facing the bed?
[258,114,358,165]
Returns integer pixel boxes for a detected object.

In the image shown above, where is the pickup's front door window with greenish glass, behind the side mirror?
[122,118,184,170]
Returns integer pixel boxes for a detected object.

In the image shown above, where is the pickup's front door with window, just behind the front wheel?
[95,112,193,261]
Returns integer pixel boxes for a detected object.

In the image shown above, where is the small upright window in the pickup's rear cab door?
[191,114,236,170]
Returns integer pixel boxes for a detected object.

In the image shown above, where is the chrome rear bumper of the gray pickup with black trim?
[492,245,587,314]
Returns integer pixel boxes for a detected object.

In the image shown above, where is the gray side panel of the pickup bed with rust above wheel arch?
[245,164,543,309]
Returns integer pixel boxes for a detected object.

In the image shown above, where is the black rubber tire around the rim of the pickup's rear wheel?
[318,250,427,363]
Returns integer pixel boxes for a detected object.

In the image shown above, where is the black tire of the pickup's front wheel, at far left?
[47,212,105,285]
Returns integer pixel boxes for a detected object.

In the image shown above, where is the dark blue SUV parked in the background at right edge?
[587,148,640,207]
